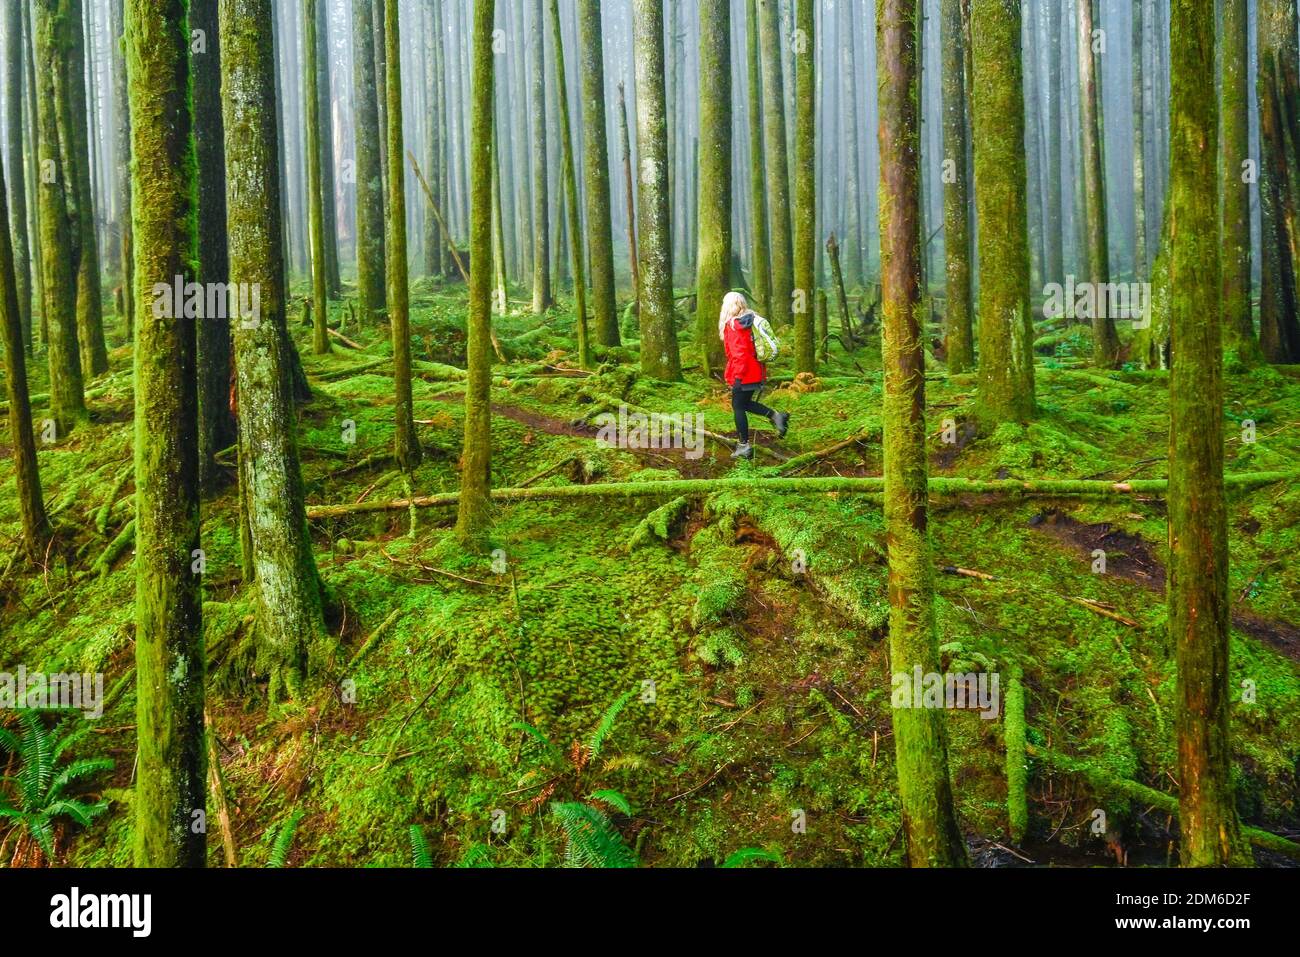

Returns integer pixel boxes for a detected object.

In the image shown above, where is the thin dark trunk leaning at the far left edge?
[0,128,49,563]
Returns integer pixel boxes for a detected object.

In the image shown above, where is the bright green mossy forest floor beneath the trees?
[0,281,1300,866]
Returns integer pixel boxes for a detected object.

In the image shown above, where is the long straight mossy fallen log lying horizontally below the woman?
[307,472,1300,520]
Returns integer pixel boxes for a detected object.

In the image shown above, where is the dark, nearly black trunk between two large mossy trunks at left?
[190,0,235,493]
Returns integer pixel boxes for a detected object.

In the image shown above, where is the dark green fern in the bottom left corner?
[0,709,113,863]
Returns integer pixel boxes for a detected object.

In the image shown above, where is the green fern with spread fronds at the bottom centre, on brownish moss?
[511,692,642,867]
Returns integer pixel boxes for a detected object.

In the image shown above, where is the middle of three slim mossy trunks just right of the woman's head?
[758,0,794,329]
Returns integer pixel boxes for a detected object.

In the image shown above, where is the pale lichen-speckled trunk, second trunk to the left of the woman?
[632,0,681,380]
